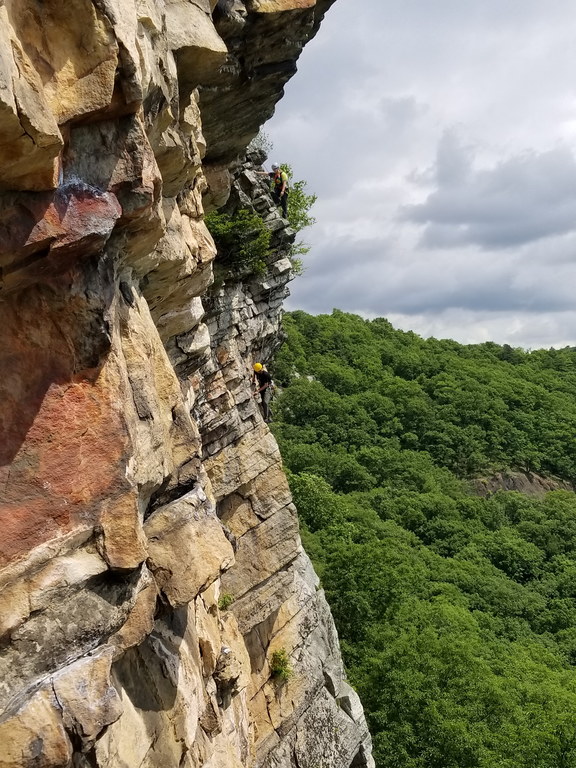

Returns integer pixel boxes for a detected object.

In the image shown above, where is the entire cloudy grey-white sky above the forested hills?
[266,0,576,348]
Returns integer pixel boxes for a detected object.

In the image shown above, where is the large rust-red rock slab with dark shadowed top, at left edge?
[0,280,137,566]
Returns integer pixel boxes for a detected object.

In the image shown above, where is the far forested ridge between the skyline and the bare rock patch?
[274,311,576,482]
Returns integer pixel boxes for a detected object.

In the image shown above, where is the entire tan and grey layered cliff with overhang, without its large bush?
[0,0,372,768]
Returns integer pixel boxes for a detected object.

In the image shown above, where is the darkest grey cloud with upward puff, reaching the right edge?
[402,134,576,250]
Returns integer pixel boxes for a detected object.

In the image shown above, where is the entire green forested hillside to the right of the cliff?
[273,310,576,768]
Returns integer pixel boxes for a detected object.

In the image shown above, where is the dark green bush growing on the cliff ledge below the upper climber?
[205,209,271,276]
